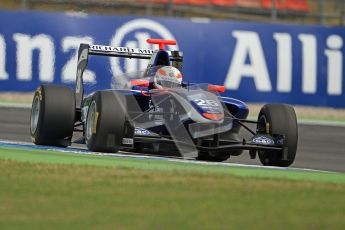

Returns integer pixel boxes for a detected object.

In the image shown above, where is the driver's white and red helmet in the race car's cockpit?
[153,66,182,89]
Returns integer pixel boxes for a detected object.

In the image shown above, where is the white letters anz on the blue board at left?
[0,33,96,83]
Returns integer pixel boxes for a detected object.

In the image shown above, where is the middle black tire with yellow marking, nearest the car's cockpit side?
[85,91,127,153]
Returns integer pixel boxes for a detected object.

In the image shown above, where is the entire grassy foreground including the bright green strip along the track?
[0,147,345,229]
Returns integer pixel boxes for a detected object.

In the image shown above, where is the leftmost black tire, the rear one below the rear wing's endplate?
[30,85,76,147]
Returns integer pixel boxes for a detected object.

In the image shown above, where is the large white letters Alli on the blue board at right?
[225,30,343,96]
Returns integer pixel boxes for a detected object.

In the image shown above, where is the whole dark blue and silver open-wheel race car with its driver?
[30,39,298,167]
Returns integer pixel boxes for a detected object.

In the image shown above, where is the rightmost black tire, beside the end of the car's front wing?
[257,104,298,167]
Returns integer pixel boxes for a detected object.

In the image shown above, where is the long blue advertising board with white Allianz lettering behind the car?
[0,11,345,107]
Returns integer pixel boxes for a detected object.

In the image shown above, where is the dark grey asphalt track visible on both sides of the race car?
[0,107,345,172]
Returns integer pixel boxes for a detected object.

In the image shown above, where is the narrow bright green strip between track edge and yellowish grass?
[0,147,345,184]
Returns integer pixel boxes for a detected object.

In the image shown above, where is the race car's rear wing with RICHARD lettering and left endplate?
[75,44,183,109]
